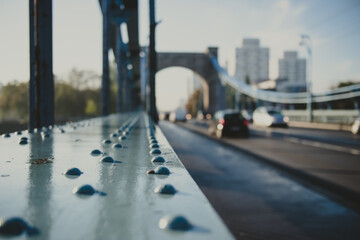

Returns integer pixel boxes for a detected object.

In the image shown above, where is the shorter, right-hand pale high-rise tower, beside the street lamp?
[276,51,306,92]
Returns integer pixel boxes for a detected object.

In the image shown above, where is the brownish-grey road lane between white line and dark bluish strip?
[179,121,360,212]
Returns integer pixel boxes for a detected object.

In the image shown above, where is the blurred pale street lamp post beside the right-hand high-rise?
[300,34,313,122]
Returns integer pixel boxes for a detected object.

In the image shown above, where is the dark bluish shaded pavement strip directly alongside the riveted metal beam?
[160,122,360,239]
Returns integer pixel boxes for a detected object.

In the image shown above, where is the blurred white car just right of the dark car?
[253,107,289,127]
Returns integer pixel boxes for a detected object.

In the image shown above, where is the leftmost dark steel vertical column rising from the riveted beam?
[29,0,54,129]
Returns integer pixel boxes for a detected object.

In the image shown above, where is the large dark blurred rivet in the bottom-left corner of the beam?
[0,217,40,237]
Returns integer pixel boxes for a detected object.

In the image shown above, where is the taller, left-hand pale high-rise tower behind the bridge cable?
[234,38,269,84]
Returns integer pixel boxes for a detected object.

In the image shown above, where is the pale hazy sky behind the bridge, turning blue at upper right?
[0,0,360,110]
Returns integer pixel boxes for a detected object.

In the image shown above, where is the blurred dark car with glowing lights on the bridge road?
[209,109,249,138]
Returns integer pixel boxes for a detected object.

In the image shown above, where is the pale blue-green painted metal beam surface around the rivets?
[0,113,233,239]
